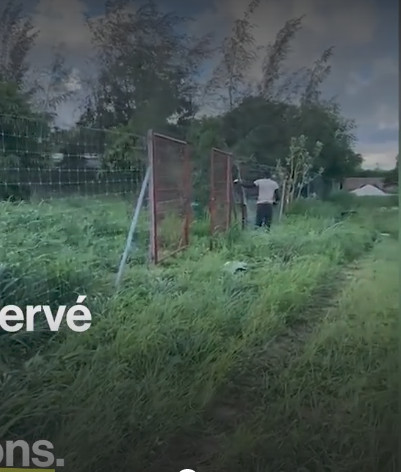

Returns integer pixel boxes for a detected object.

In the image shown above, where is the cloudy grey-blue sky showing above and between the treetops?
[24,0,399,168]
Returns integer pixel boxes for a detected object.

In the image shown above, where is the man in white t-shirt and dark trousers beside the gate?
[234,171,280,229]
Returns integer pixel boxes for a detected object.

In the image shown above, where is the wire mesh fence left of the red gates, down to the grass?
[0,115,149,306]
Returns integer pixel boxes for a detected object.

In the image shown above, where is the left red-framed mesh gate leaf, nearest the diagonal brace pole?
[148,131,192,264]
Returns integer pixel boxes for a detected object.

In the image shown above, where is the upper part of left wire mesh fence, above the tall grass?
[0,115,146,200]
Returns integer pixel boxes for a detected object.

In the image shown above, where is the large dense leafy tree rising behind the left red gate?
[82,0,208,131]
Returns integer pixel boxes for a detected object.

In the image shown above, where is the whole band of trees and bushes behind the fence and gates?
[0,0,396,194]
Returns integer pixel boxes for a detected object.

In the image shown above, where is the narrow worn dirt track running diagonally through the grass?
[151,243,390,472]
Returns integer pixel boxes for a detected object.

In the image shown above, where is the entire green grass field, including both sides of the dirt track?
[0,193,399,472]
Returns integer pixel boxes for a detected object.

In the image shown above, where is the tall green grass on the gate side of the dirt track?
[0,195,398,472]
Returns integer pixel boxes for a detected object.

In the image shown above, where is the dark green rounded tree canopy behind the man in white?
[189,97,361,183]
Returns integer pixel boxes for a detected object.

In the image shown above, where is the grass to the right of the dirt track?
[208,239,399,472]
